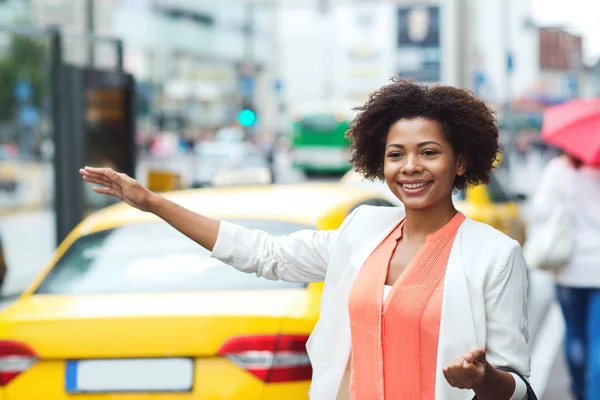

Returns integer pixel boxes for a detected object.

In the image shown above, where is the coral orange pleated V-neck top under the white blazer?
[349,213,465,400]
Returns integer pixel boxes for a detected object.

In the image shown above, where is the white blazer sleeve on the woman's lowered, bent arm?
[485,241,531,377]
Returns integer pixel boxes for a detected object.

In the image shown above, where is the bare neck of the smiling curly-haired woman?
[402,199,458,242]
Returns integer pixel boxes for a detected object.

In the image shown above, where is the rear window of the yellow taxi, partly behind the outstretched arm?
[35,220,314,294]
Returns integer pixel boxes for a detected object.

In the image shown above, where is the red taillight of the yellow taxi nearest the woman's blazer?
[218,335,312,383]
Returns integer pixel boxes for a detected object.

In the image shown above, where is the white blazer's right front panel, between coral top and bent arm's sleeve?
[435,220,477,400]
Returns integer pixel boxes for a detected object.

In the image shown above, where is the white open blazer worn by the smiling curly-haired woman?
[212,206,530,400]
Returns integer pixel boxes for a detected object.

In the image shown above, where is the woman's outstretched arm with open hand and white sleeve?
[80,167,356,282]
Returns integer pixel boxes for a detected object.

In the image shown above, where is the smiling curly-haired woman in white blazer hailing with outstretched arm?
[81,80,529,400]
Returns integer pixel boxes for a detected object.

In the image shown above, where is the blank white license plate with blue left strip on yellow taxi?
[65,358,194,393]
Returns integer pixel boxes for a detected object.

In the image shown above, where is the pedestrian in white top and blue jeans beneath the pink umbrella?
[526,153,600,400]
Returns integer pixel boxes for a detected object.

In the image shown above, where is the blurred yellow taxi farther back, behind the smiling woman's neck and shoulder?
[340,170,525,245]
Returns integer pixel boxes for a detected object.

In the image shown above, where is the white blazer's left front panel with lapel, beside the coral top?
[307,207,404,400]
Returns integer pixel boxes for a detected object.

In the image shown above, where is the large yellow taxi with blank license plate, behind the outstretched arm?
[0,183,389,400]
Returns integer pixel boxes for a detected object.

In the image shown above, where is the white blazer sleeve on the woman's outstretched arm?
[211,207,360,282]
